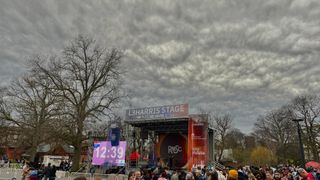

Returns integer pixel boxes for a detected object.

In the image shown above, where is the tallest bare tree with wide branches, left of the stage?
[34,36,122,171]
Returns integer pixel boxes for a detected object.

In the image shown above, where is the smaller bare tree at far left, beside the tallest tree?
[0,74,56,161]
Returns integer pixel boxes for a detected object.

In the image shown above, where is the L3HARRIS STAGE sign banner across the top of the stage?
[126,104,189,121]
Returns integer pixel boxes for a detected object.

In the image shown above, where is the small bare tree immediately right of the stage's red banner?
[213,114,233,161]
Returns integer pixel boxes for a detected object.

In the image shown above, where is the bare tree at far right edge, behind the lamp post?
[292,95,320,160]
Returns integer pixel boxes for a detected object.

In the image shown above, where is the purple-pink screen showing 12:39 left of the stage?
[92,141,127,166]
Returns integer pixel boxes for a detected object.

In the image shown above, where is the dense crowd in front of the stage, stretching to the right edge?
[128,165,320,180]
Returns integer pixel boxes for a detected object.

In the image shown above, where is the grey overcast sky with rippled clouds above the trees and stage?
[0,0,320,132]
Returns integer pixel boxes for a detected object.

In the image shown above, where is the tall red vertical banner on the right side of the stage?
[188,115,209,169]
